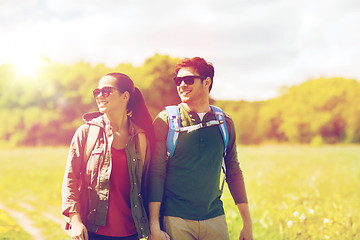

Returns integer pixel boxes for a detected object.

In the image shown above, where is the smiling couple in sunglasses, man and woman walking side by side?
[62,57,252,240]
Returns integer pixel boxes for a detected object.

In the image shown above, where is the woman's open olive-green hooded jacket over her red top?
[62,112,150,238]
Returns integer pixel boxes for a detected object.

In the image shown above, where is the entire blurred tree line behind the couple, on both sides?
[0,54,360,147]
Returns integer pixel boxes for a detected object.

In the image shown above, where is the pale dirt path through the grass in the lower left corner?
[0,203,45,240]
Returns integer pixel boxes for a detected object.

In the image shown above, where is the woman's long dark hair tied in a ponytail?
[105,73,155,149]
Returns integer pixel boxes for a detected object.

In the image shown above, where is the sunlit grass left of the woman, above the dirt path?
[0,148,69,240]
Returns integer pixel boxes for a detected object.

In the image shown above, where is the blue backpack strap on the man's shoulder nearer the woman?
[165,106,181,157]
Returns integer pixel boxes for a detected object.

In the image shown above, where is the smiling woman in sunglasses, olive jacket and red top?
[62,73,154,240]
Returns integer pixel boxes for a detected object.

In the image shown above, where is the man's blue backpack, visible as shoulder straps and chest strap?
[165,105,229,192]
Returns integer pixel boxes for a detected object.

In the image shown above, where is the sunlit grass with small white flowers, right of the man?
[223,146,360,240]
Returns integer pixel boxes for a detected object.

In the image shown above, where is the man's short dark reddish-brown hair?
[175,57,214,92]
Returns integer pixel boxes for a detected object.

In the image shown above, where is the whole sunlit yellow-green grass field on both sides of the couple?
[0,145,360,240]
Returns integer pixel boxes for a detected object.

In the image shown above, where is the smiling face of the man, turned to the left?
[176,67,209,103]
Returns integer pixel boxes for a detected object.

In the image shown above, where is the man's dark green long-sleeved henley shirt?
[149,104,247,221]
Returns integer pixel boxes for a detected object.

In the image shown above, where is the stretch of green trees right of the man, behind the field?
[217,77,360,145]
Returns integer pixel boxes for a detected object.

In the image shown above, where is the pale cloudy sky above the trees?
[0,0,360,101]
